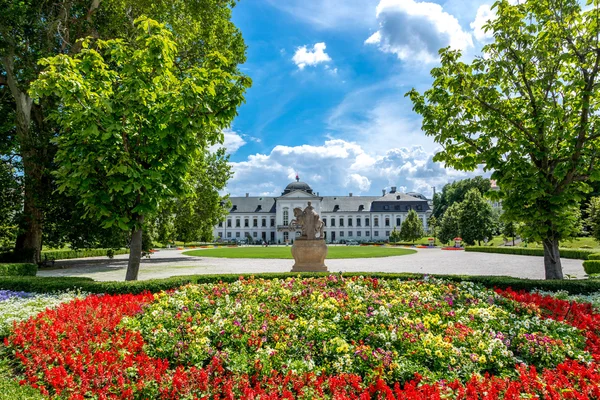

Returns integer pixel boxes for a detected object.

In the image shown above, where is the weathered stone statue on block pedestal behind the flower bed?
[289,201,327,272]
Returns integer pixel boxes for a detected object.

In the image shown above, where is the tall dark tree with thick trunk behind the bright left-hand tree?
[0,0,245,261]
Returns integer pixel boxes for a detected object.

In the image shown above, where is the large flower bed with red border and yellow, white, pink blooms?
[5,276,600,399]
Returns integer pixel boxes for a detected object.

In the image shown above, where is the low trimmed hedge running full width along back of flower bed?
[0,272,600,294]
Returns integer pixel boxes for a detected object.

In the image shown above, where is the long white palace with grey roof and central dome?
[213,176,431,244]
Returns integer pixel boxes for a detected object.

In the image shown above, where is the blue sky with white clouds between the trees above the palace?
[217,0,493,196]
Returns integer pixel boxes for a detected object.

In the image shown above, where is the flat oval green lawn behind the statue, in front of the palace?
[183,246,416,260]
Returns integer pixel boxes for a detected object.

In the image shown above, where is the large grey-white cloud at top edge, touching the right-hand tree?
[365,0,473,63]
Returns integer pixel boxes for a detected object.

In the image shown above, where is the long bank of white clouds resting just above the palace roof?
[227,139,483,197]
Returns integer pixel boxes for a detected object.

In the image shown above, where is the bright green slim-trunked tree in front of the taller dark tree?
[32,17,249,280]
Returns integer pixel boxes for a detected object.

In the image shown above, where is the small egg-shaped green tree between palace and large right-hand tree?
[458,188,494,245]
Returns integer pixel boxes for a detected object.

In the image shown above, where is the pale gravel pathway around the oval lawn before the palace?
[38,249,585,281]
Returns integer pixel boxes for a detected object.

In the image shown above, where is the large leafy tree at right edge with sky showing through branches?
[408,0,600,279]
